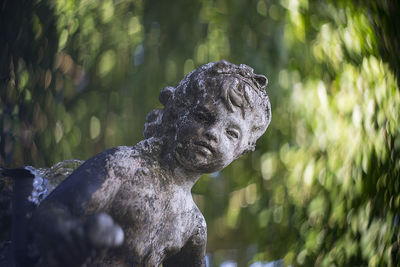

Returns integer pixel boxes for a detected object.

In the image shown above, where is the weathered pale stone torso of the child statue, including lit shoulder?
[88,147,205,266]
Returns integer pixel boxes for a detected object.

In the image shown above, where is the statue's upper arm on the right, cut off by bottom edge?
[163,219,207,267]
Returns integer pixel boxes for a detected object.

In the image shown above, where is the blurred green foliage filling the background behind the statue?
[0,0,400,266]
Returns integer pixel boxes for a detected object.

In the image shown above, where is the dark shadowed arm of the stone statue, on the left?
[31,151,123,266]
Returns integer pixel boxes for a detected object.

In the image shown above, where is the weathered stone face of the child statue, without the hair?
[174,99,249,173]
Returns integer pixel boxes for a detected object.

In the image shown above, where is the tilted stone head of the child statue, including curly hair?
[144,61,271,173]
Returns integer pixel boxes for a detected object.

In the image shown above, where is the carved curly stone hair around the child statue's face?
[143,61,271,150]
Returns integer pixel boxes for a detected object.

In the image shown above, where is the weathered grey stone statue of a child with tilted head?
[31,61,271,267]
